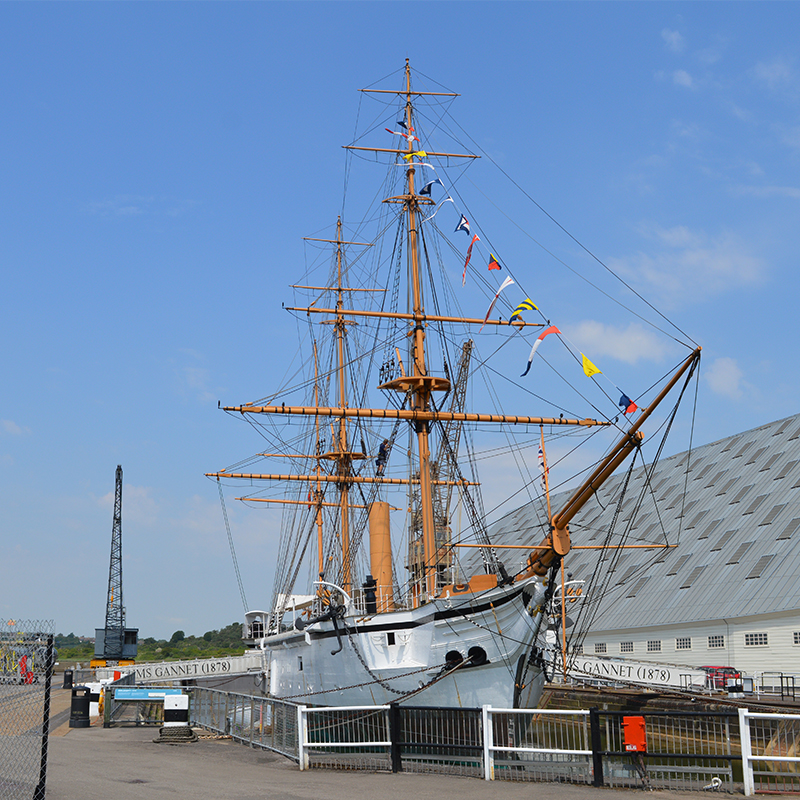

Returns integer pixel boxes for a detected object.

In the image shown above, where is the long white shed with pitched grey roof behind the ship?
[484,415,800,675]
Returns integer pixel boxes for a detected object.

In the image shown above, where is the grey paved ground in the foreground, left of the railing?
[47,690,702,800]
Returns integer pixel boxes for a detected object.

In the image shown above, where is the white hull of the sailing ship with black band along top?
[258,579,546,708]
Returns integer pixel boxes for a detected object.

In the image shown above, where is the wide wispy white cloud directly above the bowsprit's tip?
[610,225,766,304]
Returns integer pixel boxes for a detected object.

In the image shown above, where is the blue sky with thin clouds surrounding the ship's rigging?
[0,2,800,637]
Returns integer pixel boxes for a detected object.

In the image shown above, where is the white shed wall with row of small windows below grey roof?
[583,611,800,679]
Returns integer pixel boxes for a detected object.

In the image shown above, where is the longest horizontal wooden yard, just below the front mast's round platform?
[223,405,611,427]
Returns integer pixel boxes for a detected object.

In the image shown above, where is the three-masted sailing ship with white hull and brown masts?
[207,62,699,708]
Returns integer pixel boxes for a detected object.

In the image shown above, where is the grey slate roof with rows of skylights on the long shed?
[482,414,800,631]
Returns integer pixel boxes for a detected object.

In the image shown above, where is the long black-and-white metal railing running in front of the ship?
[189,687,800,794]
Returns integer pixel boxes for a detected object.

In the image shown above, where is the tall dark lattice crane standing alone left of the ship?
[91,464,139,667]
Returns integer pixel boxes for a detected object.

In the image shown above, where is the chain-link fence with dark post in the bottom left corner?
[0,619,55,800]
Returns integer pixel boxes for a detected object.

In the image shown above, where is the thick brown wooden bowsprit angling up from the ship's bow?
[525,347,702,575]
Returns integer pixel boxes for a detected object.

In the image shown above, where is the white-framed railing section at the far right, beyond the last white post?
[739,708,800,796]
